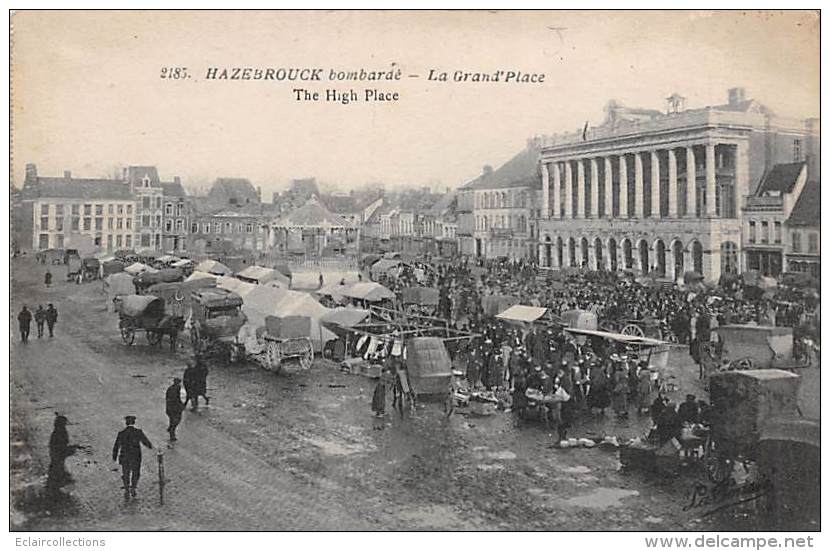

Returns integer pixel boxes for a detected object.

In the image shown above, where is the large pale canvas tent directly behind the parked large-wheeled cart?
[239,286,337,354]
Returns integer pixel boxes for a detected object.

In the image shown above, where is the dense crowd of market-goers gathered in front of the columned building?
[368,254,819,440]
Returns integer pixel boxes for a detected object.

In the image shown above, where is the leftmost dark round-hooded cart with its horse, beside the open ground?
[115,295,184,346]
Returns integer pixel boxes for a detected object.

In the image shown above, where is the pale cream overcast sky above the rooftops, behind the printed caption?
[13,12,819,197]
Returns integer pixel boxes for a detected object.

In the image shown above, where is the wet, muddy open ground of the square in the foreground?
[10,258,818,531]
